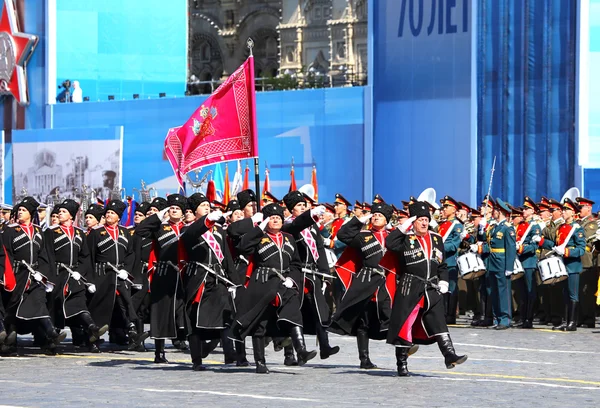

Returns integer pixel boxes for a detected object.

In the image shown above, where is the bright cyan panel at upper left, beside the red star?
[56,0,188,101]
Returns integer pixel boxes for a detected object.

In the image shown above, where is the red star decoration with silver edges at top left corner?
[0,0,38,105]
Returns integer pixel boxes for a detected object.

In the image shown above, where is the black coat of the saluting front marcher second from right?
[330,217,392,340]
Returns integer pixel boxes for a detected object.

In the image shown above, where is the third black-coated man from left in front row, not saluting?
[87,200,148,349]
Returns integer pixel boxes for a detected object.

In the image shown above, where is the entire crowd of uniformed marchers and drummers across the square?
[0,190,599,376]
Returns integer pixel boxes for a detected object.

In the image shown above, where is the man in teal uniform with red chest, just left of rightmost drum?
[516,197,542,329]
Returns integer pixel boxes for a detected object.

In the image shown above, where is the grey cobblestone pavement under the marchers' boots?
[0,318,600,407]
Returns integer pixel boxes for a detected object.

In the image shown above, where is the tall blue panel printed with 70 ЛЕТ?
[370,0,475,203]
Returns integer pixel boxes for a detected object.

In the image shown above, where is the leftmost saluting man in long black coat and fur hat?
[135,194,187,364]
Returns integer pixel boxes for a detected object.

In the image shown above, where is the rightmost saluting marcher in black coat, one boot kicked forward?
[385,201,467,377]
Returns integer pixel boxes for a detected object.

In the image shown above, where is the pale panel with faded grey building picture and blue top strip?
[8,126,123,203]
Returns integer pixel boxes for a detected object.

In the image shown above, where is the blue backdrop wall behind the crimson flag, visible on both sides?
[50,87,364,206]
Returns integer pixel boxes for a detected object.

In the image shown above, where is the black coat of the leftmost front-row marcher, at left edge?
[0,223,51,326]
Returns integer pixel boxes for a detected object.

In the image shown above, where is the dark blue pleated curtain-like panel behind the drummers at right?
[477,0,576,204]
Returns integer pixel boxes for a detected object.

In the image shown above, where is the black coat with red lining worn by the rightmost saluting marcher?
[386,230,448,346]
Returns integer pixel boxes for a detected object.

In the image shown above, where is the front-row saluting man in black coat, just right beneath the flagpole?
[230,203,317,374]
